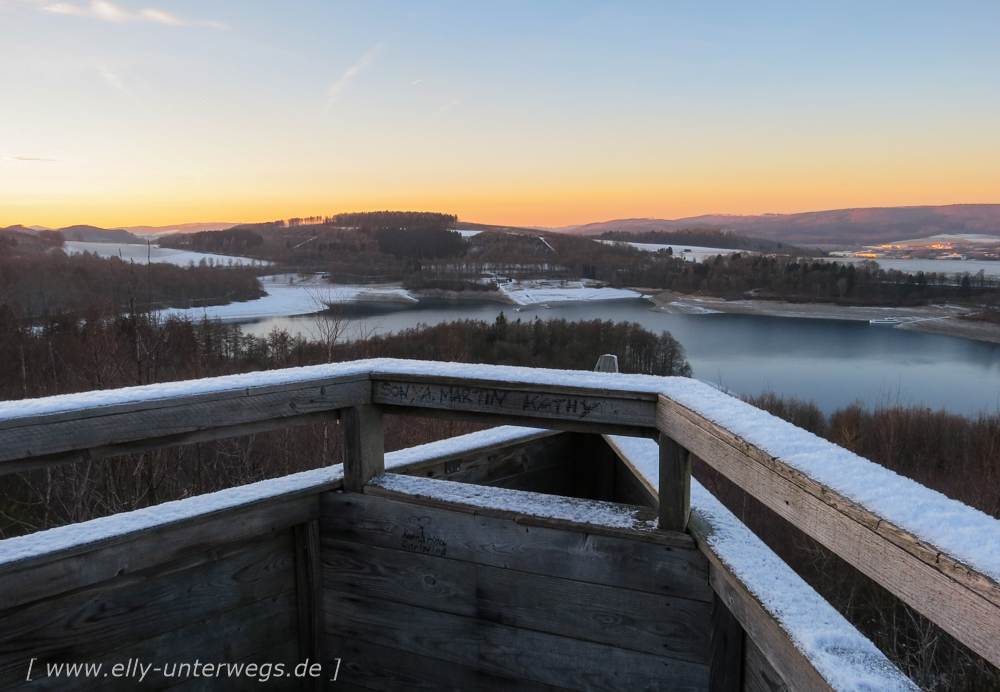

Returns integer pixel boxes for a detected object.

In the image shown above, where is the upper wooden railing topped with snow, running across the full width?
[0,359,1000,665]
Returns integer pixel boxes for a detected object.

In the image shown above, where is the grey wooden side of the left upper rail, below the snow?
[0,375,371,473]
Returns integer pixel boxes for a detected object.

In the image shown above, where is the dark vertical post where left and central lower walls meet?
[292,520,325,690]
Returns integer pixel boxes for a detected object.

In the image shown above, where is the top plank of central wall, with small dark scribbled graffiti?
[320,493,712,602]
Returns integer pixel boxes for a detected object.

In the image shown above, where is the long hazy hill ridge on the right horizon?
[562,204,1000,249]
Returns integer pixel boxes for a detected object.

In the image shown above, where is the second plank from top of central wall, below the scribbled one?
[323,539,712,664]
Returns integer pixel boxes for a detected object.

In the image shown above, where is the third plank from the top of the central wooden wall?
[326,591,708,692]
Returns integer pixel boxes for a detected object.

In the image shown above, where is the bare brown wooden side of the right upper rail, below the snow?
[658,397,1000,666]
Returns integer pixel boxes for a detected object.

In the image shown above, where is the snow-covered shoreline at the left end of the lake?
[160,274,417,322]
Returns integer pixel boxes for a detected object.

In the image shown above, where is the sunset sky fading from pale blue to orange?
[0,0,1000,227]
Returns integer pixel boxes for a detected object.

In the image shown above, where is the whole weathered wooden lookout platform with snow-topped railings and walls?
[0,360,1000,692]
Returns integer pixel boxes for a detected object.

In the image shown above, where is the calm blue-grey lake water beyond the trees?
[236,299,1000,414]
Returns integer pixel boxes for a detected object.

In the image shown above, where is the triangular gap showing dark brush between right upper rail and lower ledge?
[692,457,1000,692]
